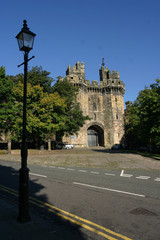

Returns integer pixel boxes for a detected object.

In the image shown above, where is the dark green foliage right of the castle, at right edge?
[126,79,160,149]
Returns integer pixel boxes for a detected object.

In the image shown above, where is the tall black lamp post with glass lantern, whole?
[16,20,36,223]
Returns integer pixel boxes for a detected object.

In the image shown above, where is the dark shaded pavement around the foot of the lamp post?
[0,194,88,240]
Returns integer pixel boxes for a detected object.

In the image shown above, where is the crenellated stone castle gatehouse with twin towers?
[63,62,125,148]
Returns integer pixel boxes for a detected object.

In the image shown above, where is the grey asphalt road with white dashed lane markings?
[0,158,160,240]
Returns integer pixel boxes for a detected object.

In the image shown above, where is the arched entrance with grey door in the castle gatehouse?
[87,125,104,147]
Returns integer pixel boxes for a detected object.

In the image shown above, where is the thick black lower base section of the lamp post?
[18,167,31,223]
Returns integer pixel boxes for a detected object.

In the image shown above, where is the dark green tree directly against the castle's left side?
[53,79,90,140]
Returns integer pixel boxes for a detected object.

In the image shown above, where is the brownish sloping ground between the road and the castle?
[0,148,160,170]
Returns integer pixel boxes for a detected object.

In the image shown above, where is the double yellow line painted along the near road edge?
[0,185,132,240]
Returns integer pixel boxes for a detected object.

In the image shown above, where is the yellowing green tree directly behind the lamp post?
[12,82,65,148]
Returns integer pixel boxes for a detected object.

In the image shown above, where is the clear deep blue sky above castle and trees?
[0,0,160,102]
